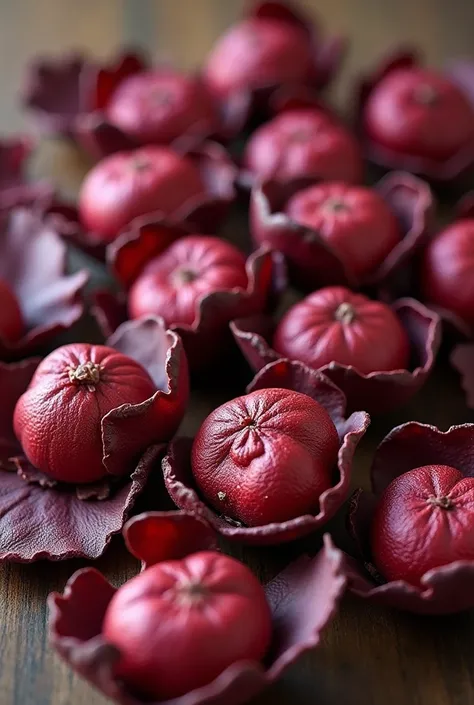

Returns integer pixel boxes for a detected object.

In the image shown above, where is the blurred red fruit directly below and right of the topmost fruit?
[244,109,363,184]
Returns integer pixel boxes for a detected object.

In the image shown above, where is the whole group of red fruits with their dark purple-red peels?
[0,0,474,705]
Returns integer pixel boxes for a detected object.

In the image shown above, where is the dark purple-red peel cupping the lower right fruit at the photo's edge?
[345,421,474,614]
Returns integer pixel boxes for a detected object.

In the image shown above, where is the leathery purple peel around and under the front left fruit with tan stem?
[0,319,188,562]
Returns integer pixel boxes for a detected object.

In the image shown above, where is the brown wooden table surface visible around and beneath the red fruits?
[0,0,474,705]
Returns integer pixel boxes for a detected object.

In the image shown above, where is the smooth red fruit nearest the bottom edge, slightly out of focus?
[103,551,271,700]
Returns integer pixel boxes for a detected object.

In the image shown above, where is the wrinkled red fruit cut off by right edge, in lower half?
[372,465,474,585]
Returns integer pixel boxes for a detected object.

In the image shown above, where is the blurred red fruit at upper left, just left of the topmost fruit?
[107,70,216,144]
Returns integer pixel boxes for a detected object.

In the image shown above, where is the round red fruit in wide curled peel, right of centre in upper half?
[285,182,401,278]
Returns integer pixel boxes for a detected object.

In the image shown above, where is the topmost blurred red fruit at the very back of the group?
[204,18,313,96]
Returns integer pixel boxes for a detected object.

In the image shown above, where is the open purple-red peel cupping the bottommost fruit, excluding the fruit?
[48,512,345,705]
